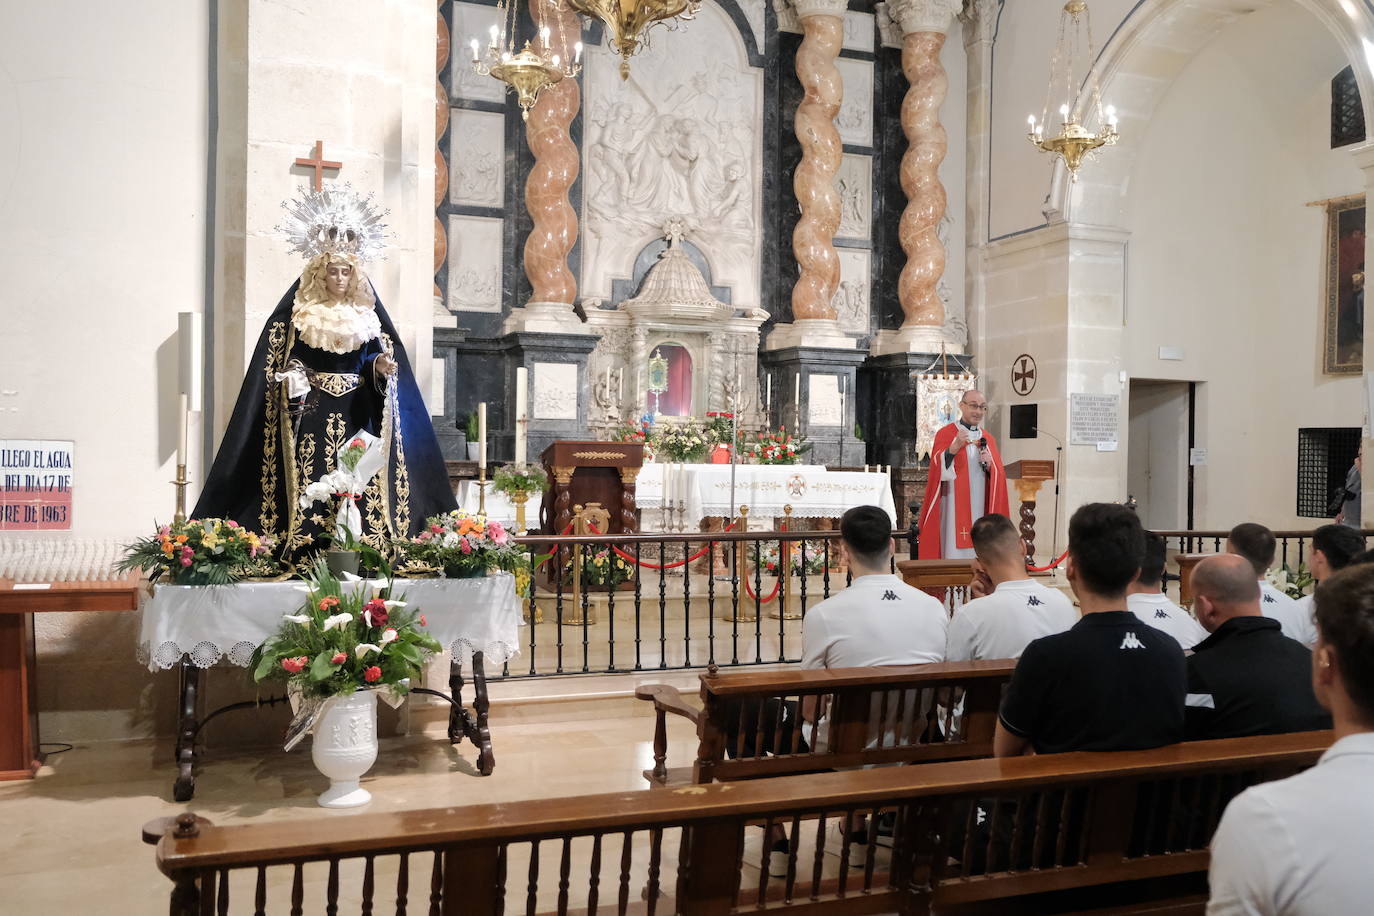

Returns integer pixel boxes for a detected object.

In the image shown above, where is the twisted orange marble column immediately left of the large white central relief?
[525,0,581,308]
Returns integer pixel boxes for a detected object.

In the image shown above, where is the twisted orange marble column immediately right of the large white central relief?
[791,0,846,320]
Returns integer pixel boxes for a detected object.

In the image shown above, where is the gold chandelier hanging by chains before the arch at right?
[1026,0,1120,181]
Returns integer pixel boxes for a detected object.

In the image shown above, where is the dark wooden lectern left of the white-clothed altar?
[539,439,644,534]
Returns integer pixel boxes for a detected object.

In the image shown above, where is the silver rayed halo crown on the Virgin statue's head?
[276,183,390,261]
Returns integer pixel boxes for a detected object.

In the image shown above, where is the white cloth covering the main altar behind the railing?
[635,463,897,525]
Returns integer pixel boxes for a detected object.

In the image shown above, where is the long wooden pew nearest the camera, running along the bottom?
[157,732,1331,916]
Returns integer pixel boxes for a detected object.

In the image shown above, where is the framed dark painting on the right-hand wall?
[1322,194,1364,375]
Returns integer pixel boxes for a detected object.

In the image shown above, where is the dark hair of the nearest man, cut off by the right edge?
[1312,564,1374,722]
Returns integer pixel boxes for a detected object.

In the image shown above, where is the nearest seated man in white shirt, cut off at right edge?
[1208,566,1374,916]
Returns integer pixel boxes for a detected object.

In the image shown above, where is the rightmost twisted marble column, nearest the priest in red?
[890,0,962,331]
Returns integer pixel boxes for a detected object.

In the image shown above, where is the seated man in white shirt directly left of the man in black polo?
[945,514,1079,662]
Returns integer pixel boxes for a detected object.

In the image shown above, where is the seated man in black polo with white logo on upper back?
[993,503,1187,757]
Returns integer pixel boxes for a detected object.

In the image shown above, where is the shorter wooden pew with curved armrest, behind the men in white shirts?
[635,659,1015,786]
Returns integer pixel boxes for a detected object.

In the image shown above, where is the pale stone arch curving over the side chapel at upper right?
[1046,0,1374,227]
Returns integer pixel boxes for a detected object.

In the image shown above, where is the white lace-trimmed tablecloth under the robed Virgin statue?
[139,573,521,672]
